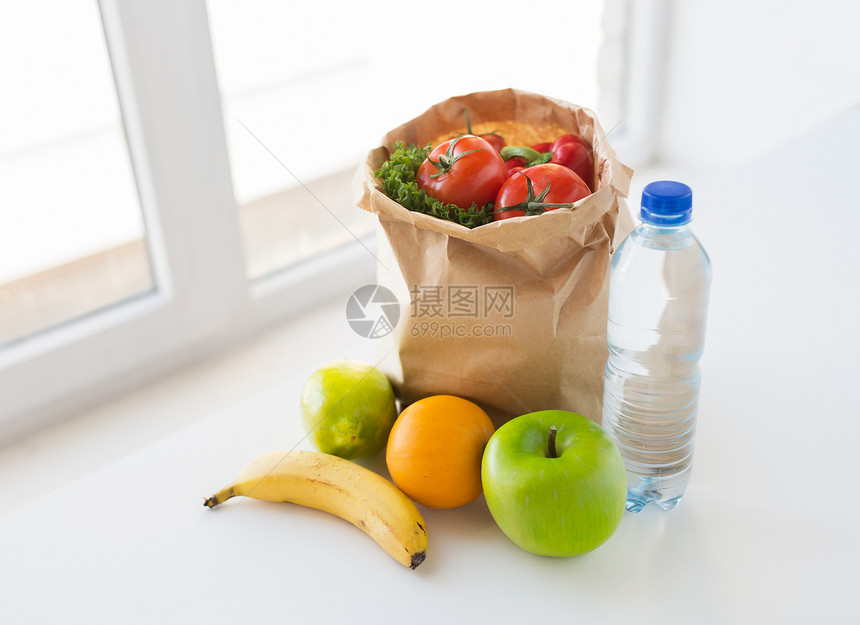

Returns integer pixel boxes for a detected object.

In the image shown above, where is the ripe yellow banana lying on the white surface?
[203,450,427,569]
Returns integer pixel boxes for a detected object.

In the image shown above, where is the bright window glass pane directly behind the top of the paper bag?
[208,0,603,277]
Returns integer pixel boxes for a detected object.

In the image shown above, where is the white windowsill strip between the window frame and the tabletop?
[0,295,366,515]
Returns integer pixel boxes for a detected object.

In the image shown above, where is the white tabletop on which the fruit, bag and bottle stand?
[0,112,860,624]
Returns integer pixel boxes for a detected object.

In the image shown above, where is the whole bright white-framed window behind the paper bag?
[0,0,659,436]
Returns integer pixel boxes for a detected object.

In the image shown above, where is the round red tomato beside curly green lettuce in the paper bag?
[415,135,508,210]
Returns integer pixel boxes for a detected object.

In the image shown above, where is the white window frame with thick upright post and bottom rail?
[0,0,666,440]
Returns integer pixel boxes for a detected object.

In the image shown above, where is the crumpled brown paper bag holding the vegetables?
[356,89,633,423]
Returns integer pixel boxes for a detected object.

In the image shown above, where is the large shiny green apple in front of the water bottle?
[481,410,627,556]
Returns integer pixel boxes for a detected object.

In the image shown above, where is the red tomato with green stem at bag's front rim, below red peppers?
[493,163,591,221]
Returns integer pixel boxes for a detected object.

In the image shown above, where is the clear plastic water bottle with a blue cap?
[603,181,711,512]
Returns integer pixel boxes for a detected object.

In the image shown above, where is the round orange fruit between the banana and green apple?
[385,395,495,508]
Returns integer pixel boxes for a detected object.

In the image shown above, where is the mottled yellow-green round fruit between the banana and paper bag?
[301,360,397,458]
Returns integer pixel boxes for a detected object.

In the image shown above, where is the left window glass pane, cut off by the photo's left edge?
[0,0,153,344]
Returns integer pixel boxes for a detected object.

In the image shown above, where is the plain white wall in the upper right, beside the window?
[659,0,860,167]
